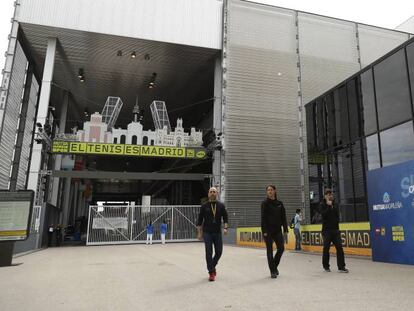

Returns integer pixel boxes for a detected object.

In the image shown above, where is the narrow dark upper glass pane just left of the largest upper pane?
[360,69,377,136]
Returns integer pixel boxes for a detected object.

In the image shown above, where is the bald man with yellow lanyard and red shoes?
[197,187,228,282]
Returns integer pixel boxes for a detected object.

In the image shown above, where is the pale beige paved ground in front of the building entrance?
[0,243,414,311]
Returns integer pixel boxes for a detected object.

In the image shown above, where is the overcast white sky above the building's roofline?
[0,0,414,70]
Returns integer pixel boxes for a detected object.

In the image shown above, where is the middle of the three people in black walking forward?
[261,185,288,279]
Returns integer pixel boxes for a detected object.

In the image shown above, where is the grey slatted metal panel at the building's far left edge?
[0,43,27,189]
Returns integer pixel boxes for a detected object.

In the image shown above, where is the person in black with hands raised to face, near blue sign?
[319,189,349,273]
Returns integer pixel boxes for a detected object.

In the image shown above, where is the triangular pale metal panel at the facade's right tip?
[358,25,409,67]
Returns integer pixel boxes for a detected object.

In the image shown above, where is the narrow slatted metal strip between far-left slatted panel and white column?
[17,77,39,190]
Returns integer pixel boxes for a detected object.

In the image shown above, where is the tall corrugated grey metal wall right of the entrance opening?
[225,0,408,226]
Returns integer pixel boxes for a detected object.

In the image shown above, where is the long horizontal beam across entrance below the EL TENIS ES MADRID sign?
[52,170,210,180]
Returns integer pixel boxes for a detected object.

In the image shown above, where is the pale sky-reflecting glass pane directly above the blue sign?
[380,121,414,166]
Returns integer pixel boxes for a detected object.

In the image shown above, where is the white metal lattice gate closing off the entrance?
[86,205,200,245]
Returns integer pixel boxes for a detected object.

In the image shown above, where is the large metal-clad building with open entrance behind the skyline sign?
[0,0,411,250]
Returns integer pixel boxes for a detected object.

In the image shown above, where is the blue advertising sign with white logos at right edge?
[367,161,414,265]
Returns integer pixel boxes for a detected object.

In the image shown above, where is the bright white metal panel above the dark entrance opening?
[18,0,223,49]
